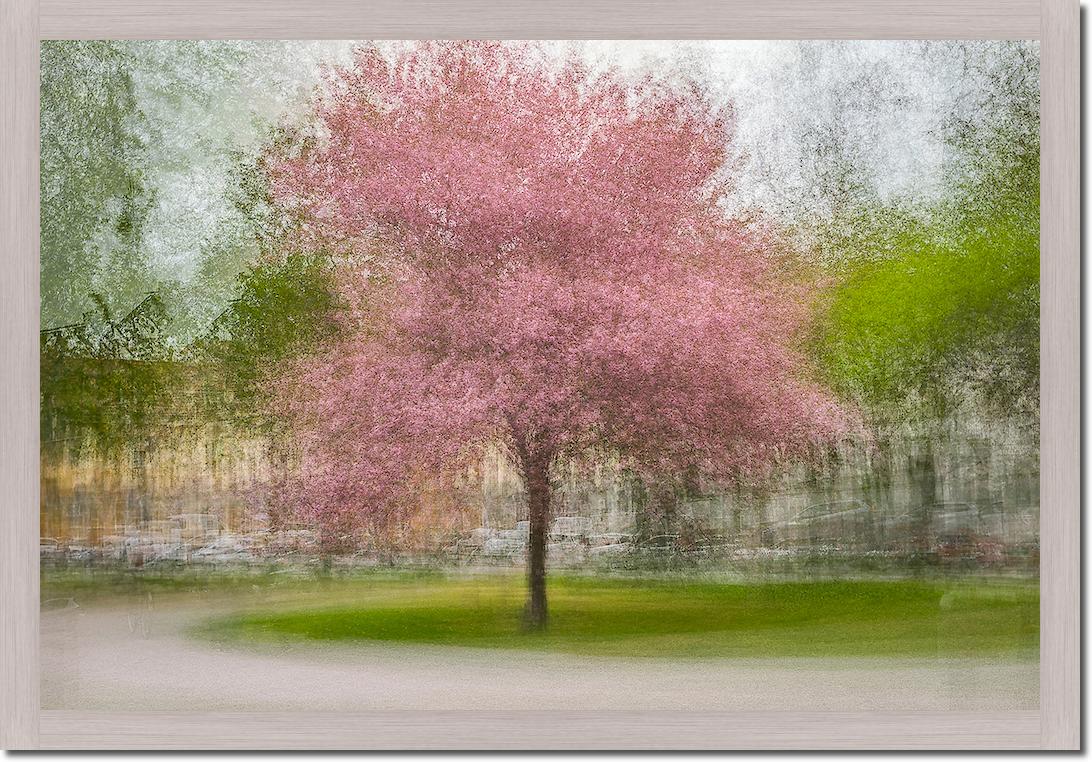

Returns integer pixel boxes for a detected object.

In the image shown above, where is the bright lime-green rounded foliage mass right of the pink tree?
[820,210,1038,419]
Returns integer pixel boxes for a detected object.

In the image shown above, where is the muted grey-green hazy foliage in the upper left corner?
[40,40,152,326]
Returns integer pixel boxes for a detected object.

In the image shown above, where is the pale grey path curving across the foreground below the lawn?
[41,596,1038,711]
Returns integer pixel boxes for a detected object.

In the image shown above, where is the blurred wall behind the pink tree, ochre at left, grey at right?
[41,410,1038,547]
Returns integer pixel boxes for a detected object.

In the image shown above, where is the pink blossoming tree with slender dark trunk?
[273,43,843,629]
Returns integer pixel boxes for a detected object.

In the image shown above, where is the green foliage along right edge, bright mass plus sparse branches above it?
[816,43,1040,419]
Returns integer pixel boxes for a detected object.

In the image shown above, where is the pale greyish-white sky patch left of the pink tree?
[125,41,353,282]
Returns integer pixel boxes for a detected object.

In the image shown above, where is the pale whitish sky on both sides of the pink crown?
[125,40,1030,278]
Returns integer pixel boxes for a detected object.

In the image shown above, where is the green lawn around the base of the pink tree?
[200,575,1038,658]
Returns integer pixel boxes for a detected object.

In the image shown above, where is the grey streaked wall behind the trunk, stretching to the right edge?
[483,417,1038,545]
